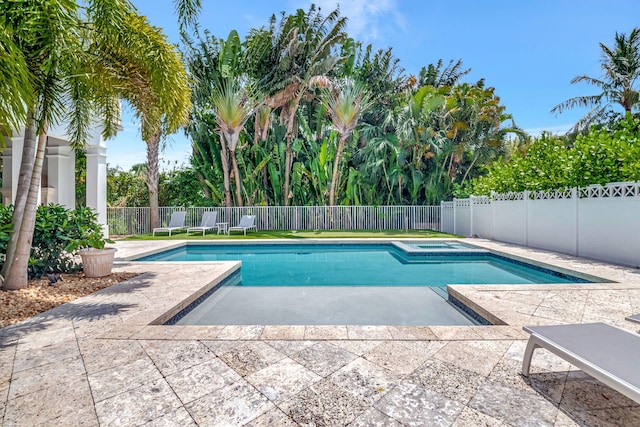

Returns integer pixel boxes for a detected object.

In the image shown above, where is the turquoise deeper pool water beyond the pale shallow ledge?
[140,245,580,289]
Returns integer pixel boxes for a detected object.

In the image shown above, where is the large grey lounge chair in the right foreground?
[522,323,640,403]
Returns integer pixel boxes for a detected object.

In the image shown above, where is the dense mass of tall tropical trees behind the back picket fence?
[179,5,523,206]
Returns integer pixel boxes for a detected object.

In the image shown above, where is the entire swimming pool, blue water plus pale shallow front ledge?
[138,242,589,325]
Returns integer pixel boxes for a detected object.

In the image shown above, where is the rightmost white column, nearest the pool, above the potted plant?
[87,141,109,236]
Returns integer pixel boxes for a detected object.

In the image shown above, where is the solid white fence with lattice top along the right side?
[442,182,640,267]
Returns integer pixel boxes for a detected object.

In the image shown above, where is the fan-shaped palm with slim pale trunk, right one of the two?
[324,80,370,206]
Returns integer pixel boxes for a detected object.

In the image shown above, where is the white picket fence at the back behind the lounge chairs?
[107,206,441,235]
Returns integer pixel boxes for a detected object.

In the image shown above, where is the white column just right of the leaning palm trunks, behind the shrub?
[47,137,76,209]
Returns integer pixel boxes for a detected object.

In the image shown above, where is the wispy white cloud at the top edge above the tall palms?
[296,0,407,41]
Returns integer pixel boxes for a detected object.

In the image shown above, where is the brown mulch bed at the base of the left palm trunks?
[0,273,139,328]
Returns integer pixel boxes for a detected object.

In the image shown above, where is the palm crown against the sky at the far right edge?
[551,28,640,132]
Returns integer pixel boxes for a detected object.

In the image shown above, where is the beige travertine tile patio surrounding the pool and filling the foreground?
[0,239,640,426]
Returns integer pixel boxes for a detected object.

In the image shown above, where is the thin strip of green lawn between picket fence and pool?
[122,230,460,240]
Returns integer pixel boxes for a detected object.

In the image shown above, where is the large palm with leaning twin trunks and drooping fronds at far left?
[0,0,188,289]
